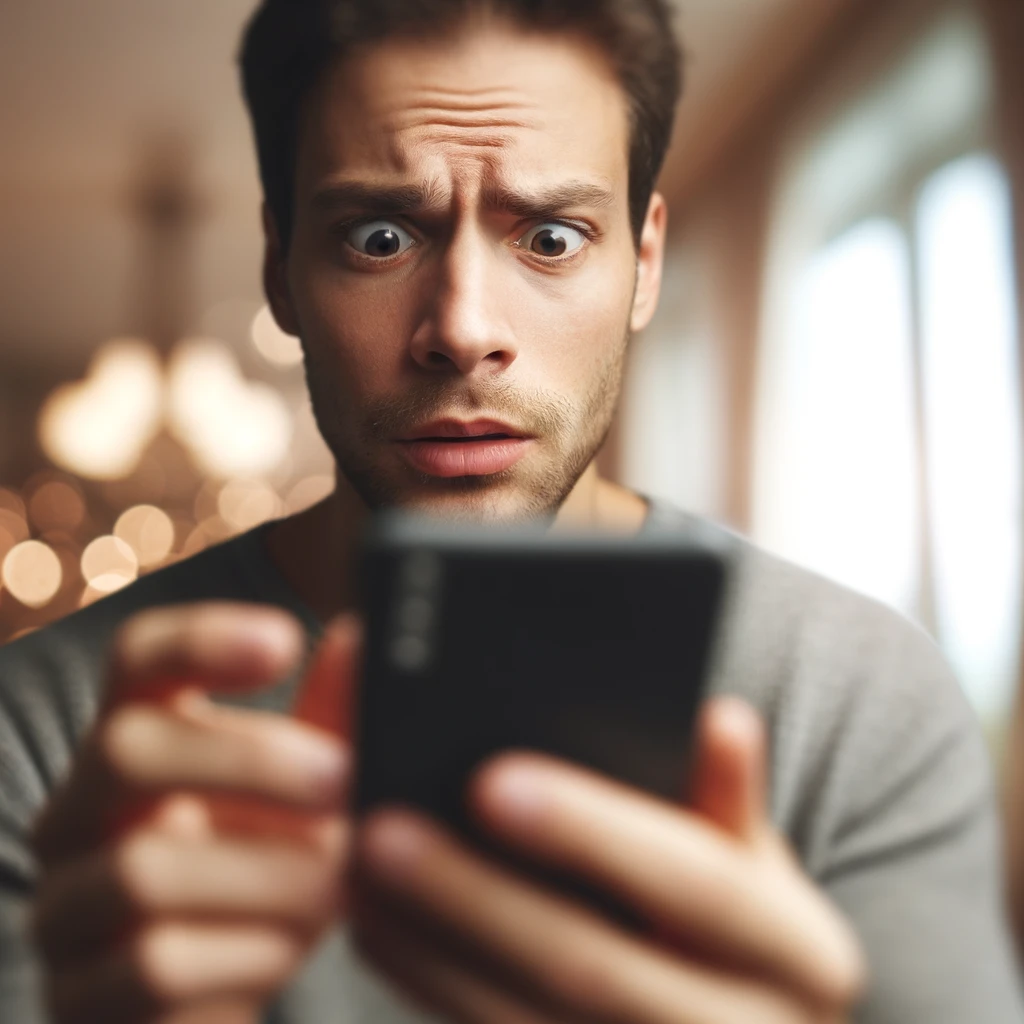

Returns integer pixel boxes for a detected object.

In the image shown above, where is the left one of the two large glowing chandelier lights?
[39,339,163,480]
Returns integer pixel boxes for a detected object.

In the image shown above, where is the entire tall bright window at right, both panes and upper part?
[754,8,1022,726]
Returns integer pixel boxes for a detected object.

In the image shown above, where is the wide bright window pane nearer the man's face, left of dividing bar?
[770,218,919,608]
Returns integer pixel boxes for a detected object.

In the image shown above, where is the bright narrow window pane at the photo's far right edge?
[918,156,1024,719]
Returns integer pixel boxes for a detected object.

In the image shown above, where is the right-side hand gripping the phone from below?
[353,700,863,1024]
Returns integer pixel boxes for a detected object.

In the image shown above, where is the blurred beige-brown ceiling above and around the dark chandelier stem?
[0,0,794,373]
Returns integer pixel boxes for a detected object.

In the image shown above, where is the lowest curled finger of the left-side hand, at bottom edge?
[49,924,304,1024]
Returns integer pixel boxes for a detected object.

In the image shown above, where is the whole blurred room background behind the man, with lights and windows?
[0,0,1024,744]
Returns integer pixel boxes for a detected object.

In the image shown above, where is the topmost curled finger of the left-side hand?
[106,602,304,709]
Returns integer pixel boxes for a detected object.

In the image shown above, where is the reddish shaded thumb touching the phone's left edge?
[293,614,362,741]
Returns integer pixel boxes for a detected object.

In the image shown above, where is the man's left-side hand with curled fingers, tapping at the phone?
[34,604,355,1024]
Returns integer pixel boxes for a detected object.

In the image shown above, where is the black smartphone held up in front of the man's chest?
[354,514,731,836]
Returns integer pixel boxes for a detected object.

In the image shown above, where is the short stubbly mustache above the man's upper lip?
[361,380,574,441]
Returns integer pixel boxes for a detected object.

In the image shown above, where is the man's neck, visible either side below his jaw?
[266,463,647,623]
